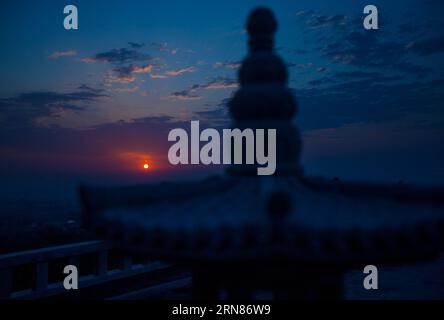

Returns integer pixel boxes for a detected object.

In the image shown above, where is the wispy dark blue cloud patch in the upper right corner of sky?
[294,10,444,83]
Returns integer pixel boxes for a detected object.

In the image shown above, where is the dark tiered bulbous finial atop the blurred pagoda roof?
[228,7,301,174]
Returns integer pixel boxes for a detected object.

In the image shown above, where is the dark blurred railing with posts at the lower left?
[0,241,175,299]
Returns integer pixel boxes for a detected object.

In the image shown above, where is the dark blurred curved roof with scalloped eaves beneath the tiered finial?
[83,177,444,265]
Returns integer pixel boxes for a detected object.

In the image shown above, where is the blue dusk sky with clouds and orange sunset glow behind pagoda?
[0,0,444,188]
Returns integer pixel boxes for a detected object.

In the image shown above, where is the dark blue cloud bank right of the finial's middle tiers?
[295,73,444,130]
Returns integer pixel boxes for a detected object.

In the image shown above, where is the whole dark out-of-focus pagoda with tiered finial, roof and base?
[81,8,444,298]
